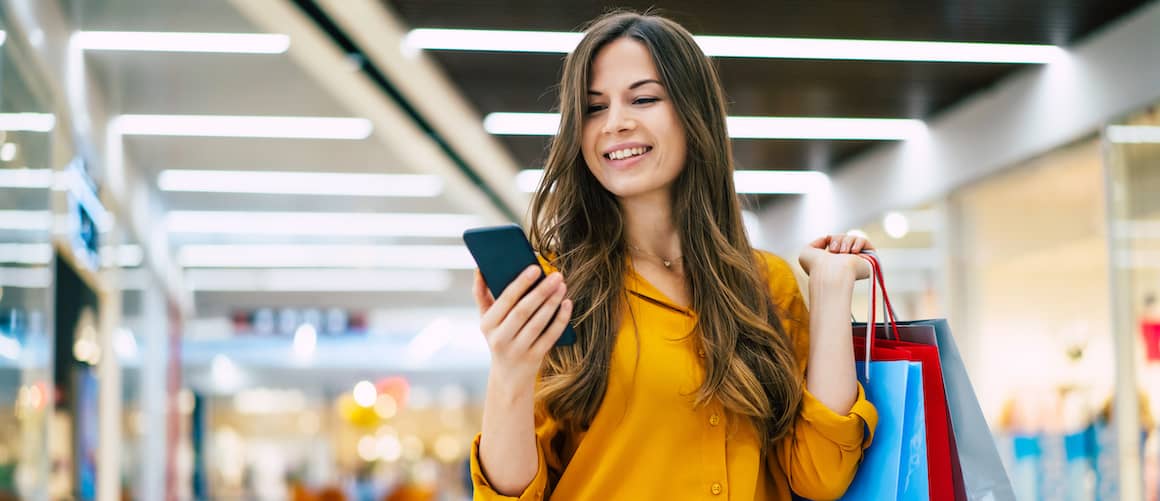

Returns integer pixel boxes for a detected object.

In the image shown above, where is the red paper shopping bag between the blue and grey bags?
[854,255,965,499]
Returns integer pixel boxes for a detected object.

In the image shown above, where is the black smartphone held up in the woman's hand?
[463,224,577,346]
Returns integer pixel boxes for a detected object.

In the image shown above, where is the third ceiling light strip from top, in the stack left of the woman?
[157,170,443,197]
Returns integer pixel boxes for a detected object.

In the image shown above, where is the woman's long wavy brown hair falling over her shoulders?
[530,12,802,446]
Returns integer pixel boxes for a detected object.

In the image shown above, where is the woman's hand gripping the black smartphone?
[474,264,572,387]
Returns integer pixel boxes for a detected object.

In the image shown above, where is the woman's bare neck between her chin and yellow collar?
[621,191,682,260]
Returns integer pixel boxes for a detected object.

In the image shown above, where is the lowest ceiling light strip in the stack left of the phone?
[186,269,451,292]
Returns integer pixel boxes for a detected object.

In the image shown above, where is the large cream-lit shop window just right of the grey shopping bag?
[949,138,1118,500]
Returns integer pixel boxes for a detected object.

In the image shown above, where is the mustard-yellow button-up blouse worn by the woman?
[471,252,878,500]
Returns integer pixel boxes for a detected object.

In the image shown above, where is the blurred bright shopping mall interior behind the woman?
[0,0,1160,501]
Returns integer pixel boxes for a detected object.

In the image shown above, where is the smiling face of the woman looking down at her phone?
[581,38,686,205]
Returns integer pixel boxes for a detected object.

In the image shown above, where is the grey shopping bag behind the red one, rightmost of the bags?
[863,253,1015,501]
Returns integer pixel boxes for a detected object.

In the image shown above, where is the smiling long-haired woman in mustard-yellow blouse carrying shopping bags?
[472,13,877,500]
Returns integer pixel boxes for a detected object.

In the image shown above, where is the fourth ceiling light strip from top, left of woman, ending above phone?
[166,211,483,237]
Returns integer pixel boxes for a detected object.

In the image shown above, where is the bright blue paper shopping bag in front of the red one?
[841,361,930,501]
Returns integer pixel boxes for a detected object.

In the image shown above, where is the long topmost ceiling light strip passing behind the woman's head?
[404,28,1067,64]
